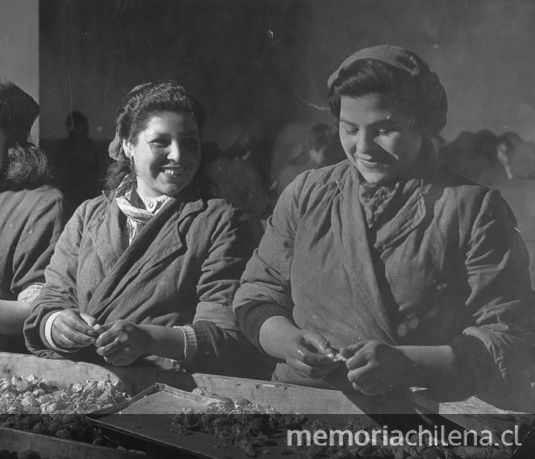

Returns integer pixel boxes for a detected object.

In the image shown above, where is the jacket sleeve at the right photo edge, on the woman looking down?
[453,190,535,393]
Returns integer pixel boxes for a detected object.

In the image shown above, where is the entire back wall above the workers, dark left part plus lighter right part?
[39,0,535,145]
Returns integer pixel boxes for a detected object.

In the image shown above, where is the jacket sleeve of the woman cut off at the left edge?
[11,193,64,295]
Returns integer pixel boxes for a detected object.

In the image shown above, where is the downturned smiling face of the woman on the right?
[339,93,422,183]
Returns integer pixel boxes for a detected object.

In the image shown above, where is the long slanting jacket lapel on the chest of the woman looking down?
[332,166,395,343]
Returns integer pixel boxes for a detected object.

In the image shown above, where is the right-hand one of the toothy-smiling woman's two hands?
[95,320,153,366]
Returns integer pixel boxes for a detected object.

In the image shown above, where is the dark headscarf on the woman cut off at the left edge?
[0,81,39,144]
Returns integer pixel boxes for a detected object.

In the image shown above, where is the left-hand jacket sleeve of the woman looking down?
[233,173,307,349]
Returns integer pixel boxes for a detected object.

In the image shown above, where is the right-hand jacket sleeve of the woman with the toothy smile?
[191,207,262,374]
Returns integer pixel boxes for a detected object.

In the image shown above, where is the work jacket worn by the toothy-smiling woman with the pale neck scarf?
[24,196,260,373]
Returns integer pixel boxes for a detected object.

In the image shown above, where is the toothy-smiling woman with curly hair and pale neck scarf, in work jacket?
[24,81,260,373]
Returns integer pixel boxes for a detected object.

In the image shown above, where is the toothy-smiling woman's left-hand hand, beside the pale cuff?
[52,309,98,350]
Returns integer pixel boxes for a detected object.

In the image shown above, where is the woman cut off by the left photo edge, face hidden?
[0,81,63,352]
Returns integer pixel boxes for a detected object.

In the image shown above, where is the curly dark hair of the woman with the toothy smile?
[104,80,206,192]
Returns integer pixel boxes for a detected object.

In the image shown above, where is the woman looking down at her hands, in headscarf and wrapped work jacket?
[234,45,533,395]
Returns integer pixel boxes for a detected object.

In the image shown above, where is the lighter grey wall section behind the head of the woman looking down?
[301,0,535,141]
